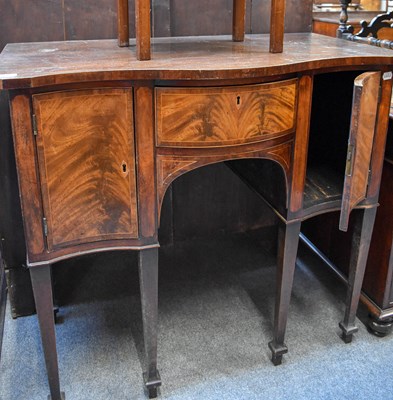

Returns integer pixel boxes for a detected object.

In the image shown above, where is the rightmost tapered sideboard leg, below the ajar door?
[339,207,377,343]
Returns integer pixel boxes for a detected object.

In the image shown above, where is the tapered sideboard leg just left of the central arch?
[139,248,161,398]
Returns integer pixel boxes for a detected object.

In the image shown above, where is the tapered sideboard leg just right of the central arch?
[269,221,301,365]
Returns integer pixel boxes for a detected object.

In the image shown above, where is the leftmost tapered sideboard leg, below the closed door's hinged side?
[30,264,65,400]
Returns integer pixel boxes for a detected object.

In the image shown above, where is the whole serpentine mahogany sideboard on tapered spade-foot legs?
[0,34,393,400]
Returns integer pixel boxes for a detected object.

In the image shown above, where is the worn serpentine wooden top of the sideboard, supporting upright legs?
[0,33,393,89]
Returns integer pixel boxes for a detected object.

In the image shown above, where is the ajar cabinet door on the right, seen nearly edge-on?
[339,72,381,231]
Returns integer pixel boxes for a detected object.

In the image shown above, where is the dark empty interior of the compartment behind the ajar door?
[303,71,359,211]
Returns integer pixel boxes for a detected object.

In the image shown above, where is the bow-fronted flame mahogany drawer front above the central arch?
[156,79,297,147]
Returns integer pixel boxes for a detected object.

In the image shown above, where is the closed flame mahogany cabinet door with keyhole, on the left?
[33,88,138,251]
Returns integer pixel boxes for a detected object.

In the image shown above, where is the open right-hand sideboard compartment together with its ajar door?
[303,71,381,231]
